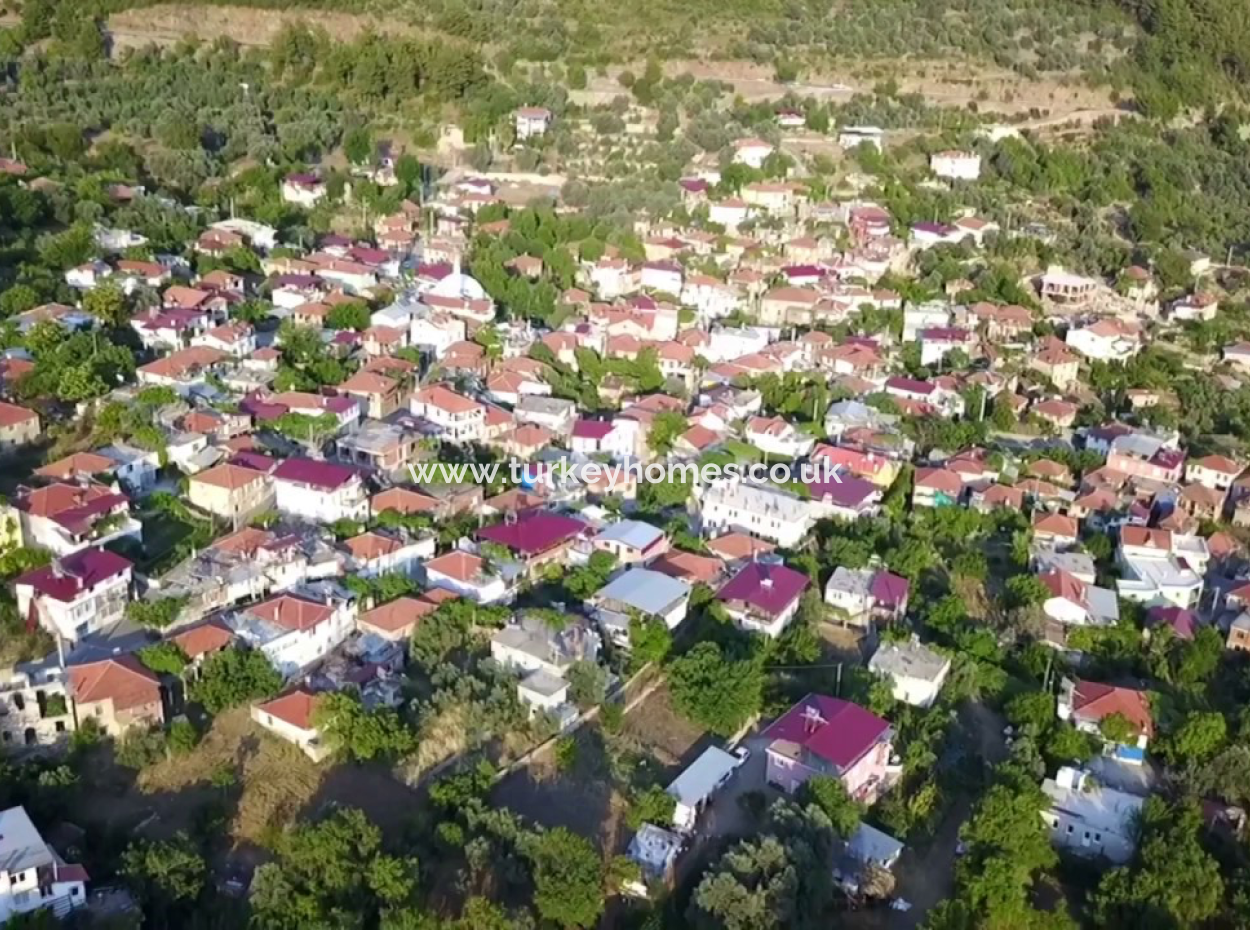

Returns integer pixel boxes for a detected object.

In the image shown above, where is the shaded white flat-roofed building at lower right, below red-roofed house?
[1041,766,1146,865]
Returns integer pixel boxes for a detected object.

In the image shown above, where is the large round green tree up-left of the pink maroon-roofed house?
[669,643,764,736]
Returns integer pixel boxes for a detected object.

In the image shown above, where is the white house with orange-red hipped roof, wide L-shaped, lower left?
[226,594,356,679]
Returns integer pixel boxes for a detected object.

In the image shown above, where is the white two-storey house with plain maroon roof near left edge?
[13,549,134,643]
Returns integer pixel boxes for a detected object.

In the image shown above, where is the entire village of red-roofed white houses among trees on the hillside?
[0,47,1250,928]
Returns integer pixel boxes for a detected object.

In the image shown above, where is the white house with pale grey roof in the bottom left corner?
[0,808,89,926]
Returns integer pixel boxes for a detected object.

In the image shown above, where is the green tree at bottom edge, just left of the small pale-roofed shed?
[523,826,604,928]
